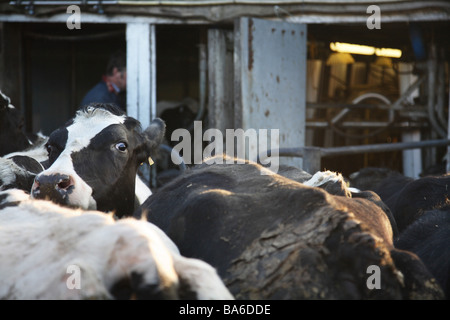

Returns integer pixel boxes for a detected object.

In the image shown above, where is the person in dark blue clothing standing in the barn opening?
[81,51,127,112]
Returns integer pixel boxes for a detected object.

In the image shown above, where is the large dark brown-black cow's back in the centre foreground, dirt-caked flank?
[135,158,443,299]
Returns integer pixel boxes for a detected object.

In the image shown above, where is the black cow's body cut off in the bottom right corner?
[395,206,450,299]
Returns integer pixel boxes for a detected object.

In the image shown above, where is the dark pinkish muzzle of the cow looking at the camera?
[31,174,75,204]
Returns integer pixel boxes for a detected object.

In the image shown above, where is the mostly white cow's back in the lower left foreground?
[0,189,233,300]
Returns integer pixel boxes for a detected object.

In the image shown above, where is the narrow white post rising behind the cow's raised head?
[126,23,156,129]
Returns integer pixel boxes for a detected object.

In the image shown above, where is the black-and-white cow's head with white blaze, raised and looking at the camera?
[31,104,165,217]
